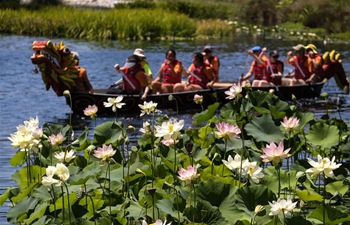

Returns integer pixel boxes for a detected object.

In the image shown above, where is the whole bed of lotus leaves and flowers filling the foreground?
[0,89,350,225]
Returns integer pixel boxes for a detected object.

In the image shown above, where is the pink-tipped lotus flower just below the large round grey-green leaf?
[260,141,291,166]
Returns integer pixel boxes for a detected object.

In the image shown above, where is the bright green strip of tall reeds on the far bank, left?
[0,7,208,40]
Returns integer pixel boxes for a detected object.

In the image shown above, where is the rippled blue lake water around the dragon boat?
[0,34,350,224]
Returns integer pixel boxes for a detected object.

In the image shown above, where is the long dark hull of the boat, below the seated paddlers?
[66,81,325,114]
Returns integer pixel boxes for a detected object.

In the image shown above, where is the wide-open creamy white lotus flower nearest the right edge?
[305,155,341,177]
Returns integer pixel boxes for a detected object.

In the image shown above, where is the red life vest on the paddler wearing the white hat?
[123,65,145,94]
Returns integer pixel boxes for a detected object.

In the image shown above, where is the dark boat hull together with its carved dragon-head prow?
[31,41,344,114]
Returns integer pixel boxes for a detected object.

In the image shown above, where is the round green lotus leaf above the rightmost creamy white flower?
[306,122,339,149]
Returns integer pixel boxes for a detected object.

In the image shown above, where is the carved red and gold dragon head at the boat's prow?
[30,41,79,96]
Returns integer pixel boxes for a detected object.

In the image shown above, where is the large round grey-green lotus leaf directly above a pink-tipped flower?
[244,114,284,143]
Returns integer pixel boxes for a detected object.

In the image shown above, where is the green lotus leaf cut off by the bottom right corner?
[307,204,350,225]
